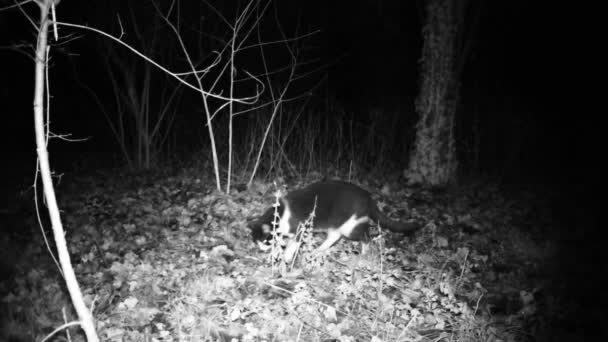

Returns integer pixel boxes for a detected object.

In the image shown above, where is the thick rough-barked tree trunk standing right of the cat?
[406,0,465,186]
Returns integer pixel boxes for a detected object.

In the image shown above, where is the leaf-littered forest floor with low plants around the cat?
[0,165,588,342]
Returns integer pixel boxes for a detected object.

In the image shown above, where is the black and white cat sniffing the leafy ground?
[249,180,419,262]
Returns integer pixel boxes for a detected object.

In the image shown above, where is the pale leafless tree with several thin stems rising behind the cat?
[156,0,317,192]
